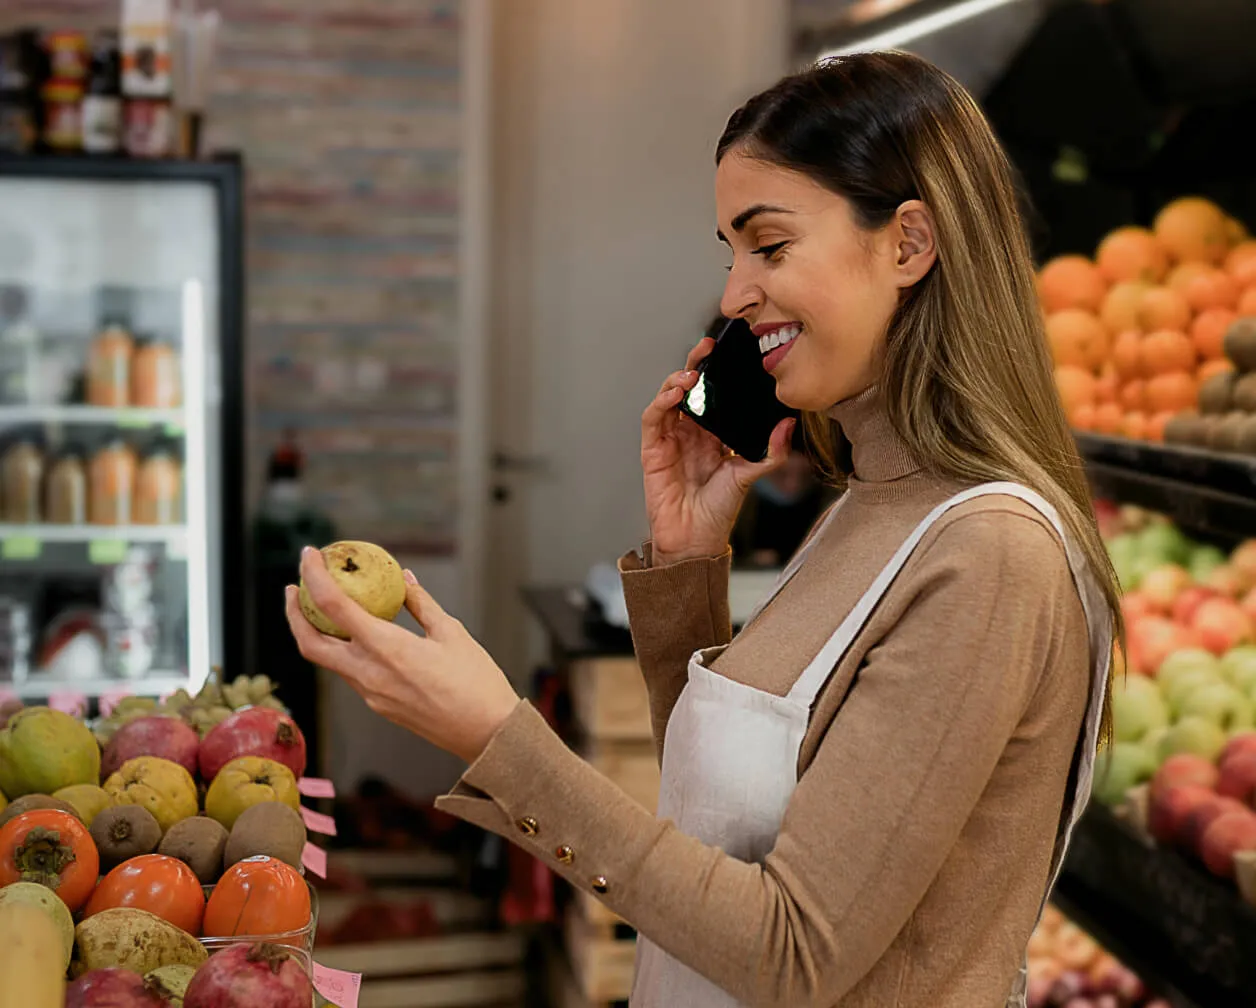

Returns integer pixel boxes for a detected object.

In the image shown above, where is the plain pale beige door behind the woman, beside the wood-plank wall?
[484,0,789,688]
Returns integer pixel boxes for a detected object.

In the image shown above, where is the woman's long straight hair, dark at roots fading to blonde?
[716,53,1124,739]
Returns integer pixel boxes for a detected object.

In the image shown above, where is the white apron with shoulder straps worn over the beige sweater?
[629,483,1112,1008]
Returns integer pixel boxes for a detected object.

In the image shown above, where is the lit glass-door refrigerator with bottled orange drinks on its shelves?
[0,157,246,709]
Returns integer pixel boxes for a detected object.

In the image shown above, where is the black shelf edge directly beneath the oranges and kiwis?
[1076,434,1256,539]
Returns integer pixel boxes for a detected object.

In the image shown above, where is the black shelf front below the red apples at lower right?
[1053,805,1256,1008]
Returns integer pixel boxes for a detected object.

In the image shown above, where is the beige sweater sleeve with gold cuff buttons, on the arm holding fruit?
[438,512,1085,1005]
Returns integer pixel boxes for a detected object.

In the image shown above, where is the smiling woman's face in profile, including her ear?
[715,151,933,412]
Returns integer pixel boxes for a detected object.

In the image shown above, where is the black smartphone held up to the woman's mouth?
[679,319,799,462]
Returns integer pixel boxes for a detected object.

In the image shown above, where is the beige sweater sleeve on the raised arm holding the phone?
[619,542,732,758]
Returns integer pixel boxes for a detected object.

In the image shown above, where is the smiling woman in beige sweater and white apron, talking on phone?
[289,54,1119,1008]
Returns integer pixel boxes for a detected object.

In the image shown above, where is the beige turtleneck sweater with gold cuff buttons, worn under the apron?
[437,390,1090,1008]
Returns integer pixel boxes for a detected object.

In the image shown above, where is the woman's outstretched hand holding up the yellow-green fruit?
[286,547,519,763]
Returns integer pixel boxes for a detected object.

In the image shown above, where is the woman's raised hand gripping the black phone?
[641,336,795,566]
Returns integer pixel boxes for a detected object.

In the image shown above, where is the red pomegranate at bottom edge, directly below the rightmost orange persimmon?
[183,941,314,1008]
